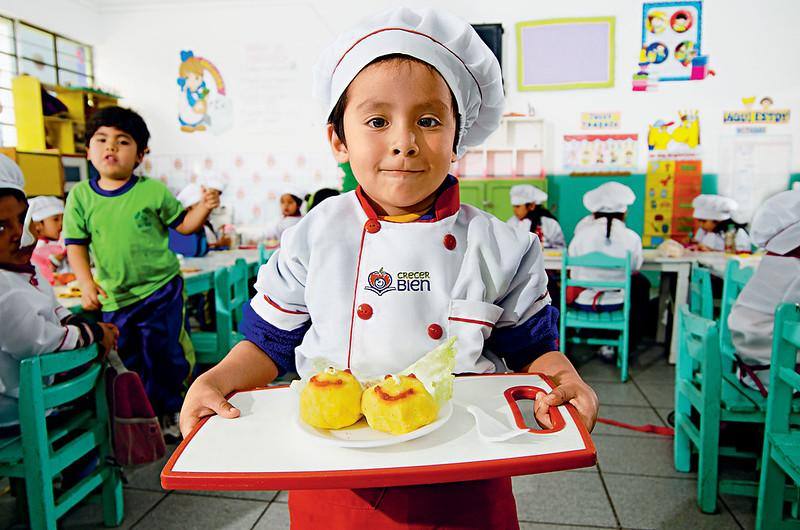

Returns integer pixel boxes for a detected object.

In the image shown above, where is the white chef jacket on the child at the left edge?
[0,269,86,426]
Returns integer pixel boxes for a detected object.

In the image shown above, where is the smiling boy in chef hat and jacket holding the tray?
[181,8,597,529]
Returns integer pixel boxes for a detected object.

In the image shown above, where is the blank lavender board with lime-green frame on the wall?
[516,17,616,91]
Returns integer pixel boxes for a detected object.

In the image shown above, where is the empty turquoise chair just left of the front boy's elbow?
[191,258,250,364]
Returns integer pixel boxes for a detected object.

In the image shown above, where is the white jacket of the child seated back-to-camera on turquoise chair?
[567,218,644,306]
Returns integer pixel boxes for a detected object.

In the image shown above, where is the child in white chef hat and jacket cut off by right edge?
[728,190,800,394]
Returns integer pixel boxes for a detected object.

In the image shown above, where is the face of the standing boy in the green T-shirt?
[86,126,144,180]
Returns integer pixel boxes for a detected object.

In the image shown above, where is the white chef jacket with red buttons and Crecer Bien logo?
[245,184,557,379]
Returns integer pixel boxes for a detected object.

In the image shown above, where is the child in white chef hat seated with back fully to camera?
[567,182,650,356]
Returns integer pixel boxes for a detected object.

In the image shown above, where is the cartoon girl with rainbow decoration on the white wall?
[178,50,233,134]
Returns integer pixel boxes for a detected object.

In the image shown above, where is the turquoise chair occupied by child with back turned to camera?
[560,252,631,382]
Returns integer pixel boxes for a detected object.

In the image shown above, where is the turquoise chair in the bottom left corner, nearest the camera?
[0,345,123,530]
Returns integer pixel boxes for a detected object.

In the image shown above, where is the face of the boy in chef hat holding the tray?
[328,60,456,215]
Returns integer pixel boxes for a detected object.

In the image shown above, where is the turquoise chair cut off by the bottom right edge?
[756,304,800,530]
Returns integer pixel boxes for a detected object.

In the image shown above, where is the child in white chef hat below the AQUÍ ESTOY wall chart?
[692,195,752,252]
